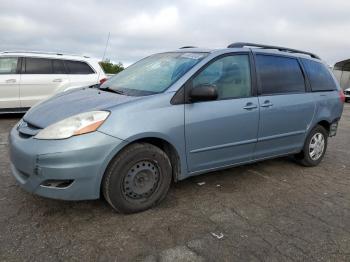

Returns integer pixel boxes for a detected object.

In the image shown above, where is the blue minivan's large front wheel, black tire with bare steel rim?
[102,143,172,214]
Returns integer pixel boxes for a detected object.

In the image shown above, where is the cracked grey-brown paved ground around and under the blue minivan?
[0,104,350,261]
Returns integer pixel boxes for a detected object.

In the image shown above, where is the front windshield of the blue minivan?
[100,52,208,96]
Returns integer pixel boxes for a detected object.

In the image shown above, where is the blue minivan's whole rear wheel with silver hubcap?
[296,126,328,166]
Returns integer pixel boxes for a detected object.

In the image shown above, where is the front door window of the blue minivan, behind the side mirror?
[192,55,251,99]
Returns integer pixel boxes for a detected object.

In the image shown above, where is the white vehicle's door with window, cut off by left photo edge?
[0,57,20,111]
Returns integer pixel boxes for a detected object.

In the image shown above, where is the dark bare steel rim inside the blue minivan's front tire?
[123,161,159,199]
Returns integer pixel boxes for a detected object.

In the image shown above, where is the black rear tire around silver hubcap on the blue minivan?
[295,125,328,167]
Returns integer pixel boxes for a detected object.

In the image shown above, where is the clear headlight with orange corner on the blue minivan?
[34,111,110,139]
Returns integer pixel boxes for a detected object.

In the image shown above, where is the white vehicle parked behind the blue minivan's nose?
[0,51,106,113]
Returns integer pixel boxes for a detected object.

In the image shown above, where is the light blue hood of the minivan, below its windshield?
[23,88,140,128]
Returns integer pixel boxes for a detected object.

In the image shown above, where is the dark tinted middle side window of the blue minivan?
[256,55,305,95]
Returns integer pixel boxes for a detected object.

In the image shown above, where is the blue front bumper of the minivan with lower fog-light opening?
[9,128,125,200]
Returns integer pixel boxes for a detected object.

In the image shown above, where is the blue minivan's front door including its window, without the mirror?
[185,54,259,172]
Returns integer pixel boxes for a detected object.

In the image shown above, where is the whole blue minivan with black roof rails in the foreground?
[10,43,345,213]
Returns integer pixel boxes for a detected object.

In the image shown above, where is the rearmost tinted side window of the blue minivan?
[303,59,337,92]
